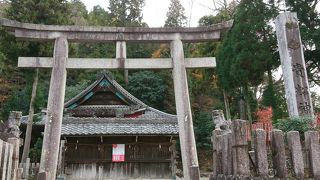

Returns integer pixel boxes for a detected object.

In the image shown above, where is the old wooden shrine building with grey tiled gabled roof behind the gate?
[22,74,179,179]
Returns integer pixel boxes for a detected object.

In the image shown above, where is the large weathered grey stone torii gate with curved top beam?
[0,19,232,180]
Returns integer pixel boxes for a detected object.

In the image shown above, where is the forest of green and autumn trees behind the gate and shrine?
[0,0,320,169]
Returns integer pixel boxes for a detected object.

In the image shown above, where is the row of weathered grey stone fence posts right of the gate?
[211,120,320,179]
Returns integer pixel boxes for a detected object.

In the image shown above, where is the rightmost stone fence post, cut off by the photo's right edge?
[304,131,320,179]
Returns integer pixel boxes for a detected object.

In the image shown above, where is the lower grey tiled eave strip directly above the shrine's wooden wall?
[61,118,179,136]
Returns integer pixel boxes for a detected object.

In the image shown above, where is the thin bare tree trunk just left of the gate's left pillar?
[21,69,39,163]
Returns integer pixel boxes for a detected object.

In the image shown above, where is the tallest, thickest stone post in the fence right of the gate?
[231,120,250,177]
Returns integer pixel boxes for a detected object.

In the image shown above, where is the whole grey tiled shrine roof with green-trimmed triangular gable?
[21,74,179,136]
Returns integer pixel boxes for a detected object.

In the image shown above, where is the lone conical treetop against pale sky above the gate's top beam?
[164,0,187,27]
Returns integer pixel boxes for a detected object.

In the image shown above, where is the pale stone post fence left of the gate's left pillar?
[0,138,22,180]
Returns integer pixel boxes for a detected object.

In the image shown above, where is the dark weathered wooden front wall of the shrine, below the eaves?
[64,136,174,179]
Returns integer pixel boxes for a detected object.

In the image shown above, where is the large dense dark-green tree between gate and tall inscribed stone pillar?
[217,0,278,121]
